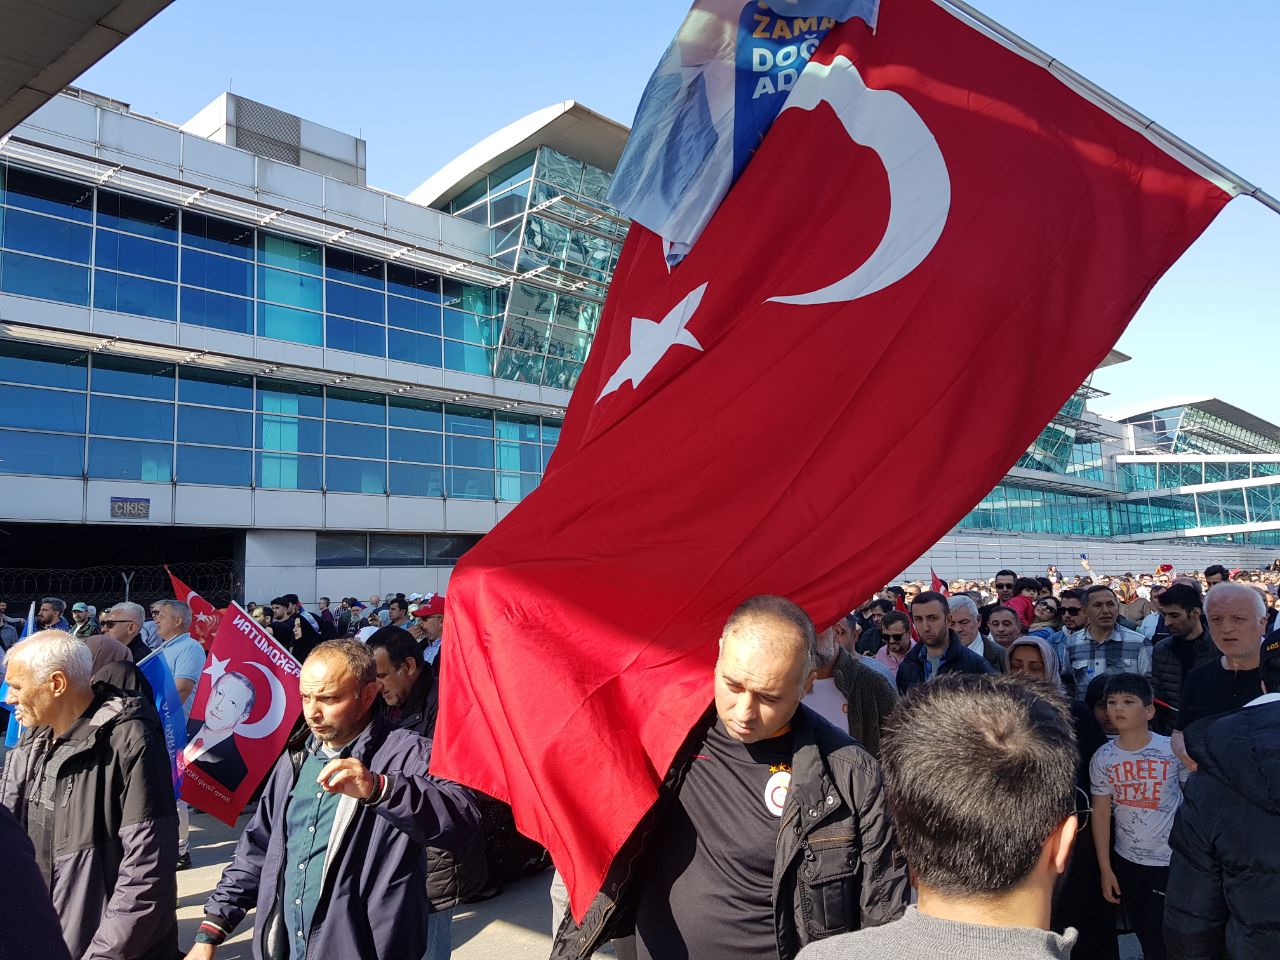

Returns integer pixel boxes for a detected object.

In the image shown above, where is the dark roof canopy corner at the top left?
[0,0,170,134]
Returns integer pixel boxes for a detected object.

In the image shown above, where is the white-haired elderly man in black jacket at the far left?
[0,630,178,960]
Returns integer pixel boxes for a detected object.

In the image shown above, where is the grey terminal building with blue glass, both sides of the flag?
[0,88,1280,600]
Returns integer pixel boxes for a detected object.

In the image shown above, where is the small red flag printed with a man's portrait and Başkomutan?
[178,603,302,827]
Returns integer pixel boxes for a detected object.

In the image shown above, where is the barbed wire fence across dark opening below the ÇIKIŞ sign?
[0,558,244,617]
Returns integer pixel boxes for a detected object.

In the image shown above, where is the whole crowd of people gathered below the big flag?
[0,561,1280,960]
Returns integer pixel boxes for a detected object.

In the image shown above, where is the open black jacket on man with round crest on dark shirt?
[552,704,909,960]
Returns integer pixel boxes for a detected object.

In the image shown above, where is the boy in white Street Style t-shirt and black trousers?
[1089,673,1188,960]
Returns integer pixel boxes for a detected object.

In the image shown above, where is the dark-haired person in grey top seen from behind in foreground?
[797,673,1076,960]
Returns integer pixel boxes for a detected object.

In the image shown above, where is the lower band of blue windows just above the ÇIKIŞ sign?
[0,340,561,504]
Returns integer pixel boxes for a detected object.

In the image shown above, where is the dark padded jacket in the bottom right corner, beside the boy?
[1165,700,1280,960]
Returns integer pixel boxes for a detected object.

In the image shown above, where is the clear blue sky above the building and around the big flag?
[79,0,1280,425]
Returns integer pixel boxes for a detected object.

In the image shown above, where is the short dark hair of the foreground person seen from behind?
[881,673,1079,896]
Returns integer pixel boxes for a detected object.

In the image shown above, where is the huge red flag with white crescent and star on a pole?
[433,0,1230,916]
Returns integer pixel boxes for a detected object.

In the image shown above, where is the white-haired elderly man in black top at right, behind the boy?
[1170,582,1267,771]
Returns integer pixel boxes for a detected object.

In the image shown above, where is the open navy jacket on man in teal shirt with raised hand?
[205,716,480,960]
